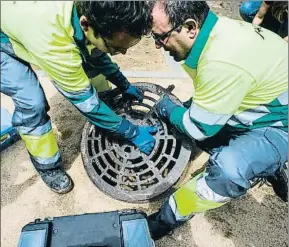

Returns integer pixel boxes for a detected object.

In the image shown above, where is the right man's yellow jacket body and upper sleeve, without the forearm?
[184,14,288,130]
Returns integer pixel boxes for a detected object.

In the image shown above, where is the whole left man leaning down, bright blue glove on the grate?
[1,1,156,193]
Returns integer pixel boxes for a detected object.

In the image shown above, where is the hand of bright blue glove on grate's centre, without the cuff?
[132,126,158,155]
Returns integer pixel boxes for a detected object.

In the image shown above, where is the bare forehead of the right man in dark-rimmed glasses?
[152,1,171,33]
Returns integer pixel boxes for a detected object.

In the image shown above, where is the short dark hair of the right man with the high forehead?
[163,1,210,28]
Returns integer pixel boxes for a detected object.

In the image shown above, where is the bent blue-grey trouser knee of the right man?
[206,151,250,198]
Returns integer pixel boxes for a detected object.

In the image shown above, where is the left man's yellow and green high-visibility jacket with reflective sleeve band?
[0,1,126,131]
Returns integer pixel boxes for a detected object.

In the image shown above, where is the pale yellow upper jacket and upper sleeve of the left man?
[1,1,89,91]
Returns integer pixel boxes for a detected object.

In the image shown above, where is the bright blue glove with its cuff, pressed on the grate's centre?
[115,119,157,155]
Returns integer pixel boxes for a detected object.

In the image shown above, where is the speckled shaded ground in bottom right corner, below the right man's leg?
[205,188,288,247]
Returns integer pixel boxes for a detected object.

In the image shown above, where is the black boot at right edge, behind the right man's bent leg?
[267,165,288,202]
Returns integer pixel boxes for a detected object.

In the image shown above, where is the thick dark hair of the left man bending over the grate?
[76,1,152,38]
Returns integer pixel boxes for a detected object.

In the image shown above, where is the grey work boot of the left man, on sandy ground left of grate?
[38,167,73,194]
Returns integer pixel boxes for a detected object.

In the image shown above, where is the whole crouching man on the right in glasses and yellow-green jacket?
[145,1,288,239]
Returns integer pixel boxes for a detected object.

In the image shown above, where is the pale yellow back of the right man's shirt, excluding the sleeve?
[204,17,288,106]
